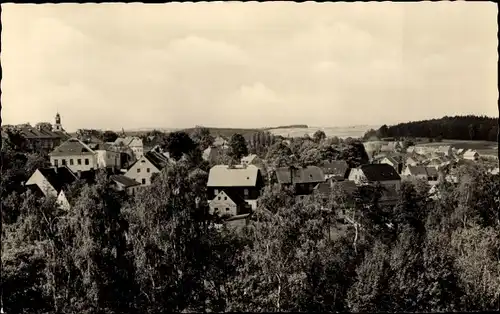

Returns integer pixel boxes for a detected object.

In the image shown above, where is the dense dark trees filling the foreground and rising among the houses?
[1,129,500,313]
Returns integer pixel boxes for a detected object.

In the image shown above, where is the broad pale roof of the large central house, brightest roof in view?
[207,165,260,187]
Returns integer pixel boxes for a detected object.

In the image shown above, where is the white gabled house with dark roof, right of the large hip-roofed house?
[125,151,170,186]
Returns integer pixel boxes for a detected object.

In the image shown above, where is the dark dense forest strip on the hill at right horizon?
[364,115,498,141]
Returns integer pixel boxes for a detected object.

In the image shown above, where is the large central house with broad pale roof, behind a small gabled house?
[207,165,264,209]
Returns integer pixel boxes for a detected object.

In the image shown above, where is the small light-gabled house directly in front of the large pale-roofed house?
[209,189,252,217]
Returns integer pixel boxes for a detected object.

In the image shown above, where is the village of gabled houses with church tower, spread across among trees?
[2,114,499,221]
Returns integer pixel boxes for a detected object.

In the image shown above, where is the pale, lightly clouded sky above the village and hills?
[1,1,498,131]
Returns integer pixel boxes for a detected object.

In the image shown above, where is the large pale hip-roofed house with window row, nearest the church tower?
[49,138,121,172]
